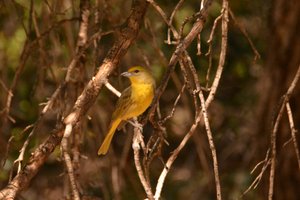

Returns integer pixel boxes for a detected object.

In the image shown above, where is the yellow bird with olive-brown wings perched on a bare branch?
[98,66,155,155]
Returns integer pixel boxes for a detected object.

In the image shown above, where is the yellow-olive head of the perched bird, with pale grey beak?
[121,66,155,85]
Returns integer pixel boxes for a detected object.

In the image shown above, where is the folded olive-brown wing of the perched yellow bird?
[112,87,133,120]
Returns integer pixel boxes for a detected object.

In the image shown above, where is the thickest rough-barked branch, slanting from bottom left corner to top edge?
[0,0,148,199]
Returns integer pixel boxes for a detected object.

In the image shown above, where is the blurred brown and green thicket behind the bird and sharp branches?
[0,0,300,200]
